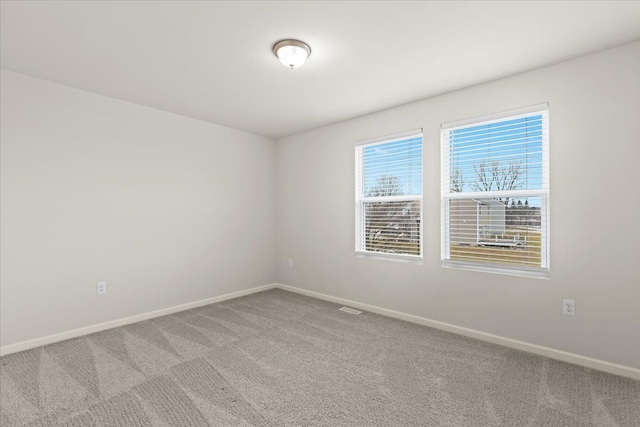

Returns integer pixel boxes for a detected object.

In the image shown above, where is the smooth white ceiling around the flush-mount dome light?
[0,1,640,138]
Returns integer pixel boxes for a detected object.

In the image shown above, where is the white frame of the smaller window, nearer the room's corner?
[355,128,424,263]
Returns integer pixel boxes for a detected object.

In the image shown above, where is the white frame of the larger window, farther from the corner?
[440,103,550,279]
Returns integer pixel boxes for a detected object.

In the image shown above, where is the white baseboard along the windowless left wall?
[0,283,276,356]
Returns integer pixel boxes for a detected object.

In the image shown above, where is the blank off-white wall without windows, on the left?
[0,70,276,346]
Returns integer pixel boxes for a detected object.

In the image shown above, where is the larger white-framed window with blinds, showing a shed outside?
[442,104,549,277]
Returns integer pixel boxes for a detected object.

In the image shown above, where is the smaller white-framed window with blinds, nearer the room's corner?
[356,130,422,259]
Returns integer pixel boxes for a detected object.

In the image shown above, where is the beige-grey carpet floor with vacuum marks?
[0,290,640,427]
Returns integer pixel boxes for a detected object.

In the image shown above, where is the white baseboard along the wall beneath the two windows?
[275,283,640,380]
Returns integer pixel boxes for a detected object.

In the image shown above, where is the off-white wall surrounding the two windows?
[277,42,640,368]
